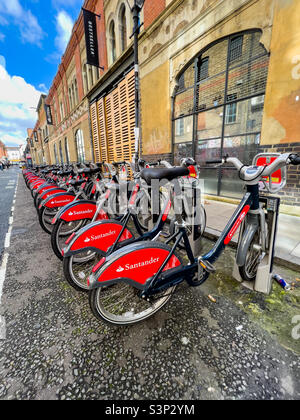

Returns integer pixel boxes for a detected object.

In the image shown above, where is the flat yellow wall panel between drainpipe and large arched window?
[141,62,172,155]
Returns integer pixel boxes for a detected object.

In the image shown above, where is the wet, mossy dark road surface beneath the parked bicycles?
[0,177,300,400]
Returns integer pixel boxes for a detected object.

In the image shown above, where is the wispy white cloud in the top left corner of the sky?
[0,0,45,46]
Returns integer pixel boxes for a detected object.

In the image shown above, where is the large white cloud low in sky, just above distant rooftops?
[0,60,42,144]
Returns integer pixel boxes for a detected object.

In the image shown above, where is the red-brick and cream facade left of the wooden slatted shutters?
[46,0,107,164]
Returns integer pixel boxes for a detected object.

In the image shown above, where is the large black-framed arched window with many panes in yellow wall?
[173,31,269,197]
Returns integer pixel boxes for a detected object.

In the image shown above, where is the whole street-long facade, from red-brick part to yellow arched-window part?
[27,0,300,206]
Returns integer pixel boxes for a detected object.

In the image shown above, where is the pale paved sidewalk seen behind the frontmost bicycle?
[205,199,300,269]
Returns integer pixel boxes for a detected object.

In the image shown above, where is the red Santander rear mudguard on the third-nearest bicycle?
[52,200,108,224]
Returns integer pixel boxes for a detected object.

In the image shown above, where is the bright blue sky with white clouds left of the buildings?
[0,0,83,146]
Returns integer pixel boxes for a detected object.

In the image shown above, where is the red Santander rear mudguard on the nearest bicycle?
[88,242,182,290]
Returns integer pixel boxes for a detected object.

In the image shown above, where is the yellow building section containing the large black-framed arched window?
[139,0,300,205]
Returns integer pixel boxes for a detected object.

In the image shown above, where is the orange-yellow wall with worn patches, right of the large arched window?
[261,0,300,144]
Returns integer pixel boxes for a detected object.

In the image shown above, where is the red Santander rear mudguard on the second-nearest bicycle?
[63,220,134,257]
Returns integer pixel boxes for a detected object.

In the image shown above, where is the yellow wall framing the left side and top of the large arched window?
[139,0,278,155]
